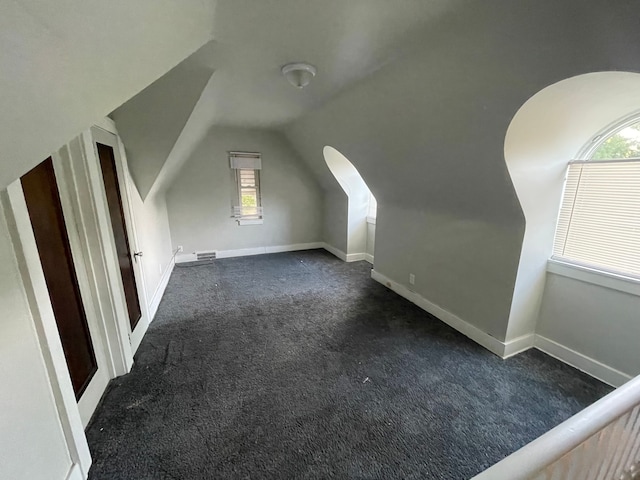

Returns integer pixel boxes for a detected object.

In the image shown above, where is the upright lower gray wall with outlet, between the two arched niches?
[375,203,519,340]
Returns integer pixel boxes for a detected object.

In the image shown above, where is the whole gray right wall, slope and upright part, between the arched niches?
[286,0,640,340]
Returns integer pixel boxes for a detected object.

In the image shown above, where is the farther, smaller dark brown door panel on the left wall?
[96,143,142,331]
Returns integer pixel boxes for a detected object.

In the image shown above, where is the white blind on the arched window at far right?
[553,159,640,278]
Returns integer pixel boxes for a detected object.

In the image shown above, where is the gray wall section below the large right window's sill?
[537,273,640,376]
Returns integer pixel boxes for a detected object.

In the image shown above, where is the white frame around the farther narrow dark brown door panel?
[82,118,151,354]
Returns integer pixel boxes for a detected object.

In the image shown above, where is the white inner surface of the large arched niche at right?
[504,72,640,341]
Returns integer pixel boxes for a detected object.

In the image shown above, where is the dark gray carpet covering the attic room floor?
[87,250,610,480]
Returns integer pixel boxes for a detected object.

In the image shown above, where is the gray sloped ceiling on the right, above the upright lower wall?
[286,0,640,220]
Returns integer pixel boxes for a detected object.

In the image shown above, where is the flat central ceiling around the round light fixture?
[202,0,460,128]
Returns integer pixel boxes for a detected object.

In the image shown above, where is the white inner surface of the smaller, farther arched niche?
[322,145,376,260]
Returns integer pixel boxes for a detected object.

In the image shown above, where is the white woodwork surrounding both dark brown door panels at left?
[0,119,150,479]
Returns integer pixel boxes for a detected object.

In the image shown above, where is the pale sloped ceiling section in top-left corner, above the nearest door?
[0,0,215,187]
